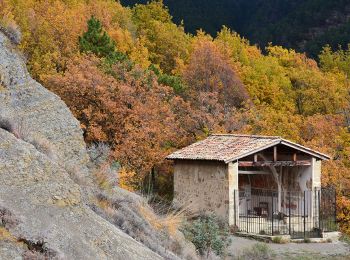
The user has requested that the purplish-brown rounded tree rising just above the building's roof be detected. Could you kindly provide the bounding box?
[183,40,248,132]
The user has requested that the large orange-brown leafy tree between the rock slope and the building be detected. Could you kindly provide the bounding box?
[49,56,183,189]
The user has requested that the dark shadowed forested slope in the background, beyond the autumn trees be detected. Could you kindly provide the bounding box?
[121,0,350,58]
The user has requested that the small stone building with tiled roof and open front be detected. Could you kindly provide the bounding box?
[167,134,330,238]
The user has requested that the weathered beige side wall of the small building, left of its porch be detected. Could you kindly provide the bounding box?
[174,160,232,221]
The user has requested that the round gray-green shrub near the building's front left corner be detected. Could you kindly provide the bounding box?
[182,215,230,257]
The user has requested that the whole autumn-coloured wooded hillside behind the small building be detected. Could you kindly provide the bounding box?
[0,0,350,235]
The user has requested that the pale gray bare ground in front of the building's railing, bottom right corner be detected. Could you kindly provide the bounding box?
[228,236,350,259]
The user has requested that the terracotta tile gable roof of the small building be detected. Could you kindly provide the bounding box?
[167,134,329,163]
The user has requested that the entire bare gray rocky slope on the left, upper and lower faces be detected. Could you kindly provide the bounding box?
[0,32,161,259]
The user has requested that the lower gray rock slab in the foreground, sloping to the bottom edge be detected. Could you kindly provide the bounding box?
[0,129,160,259]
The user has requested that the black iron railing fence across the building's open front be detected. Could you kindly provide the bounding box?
[234,189,337,238]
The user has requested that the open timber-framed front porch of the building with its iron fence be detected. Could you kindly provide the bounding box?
[233,144,337,238]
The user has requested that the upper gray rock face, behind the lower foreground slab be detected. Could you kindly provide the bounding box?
[0,31,88,169]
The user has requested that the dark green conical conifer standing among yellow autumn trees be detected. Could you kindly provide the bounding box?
[79,16,116,58]
